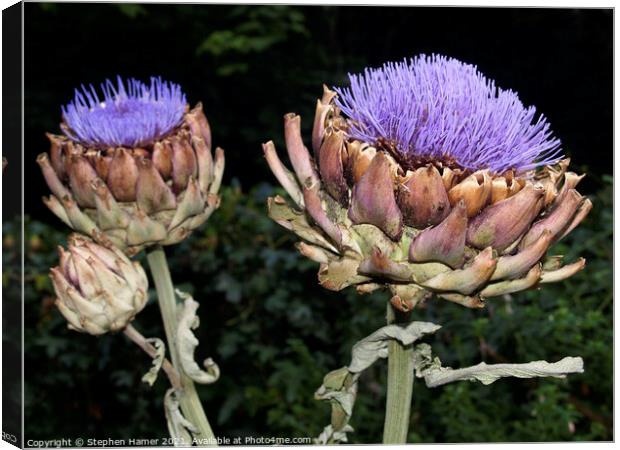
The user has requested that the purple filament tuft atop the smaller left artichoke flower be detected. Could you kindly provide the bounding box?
[62,77,187,148]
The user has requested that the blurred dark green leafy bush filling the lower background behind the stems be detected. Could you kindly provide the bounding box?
[13,178,613,443]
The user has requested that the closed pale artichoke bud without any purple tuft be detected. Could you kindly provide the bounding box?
[50,234,148,335]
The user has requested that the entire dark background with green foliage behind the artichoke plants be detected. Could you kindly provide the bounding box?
[12,4,613,443]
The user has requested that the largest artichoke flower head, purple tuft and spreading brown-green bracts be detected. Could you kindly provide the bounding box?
[263,55,592,311]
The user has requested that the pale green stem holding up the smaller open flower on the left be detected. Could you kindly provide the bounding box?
[147,246,215,445]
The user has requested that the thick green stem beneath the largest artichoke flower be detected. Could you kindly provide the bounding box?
[383,303,414,444]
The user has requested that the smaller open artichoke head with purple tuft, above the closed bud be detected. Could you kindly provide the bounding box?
[37,77,224,255]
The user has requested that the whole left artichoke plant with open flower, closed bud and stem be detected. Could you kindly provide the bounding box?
[37,77,224,445]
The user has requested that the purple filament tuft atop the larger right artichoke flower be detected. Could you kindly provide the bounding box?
[334,55,562,173]
